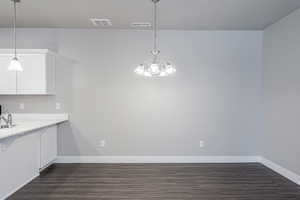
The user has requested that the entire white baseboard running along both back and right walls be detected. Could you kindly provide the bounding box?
[56,156,300,185]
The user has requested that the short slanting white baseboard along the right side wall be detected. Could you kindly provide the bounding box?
[260,157,300,185]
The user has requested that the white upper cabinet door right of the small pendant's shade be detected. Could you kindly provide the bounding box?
[17,54,46,94]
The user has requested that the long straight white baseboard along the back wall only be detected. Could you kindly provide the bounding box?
[56,156,259,163]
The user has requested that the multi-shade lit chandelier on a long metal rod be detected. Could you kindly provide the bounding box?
[134,0,176,77]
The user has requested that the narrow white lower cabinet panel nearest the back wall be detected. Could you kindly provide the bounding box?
[40,126,57,169]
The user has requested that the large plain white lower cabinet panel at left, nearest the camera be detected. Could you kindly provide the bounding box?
[0,133,40,199]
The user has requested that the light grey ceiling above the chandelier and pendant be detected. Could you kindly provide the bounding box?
[0,0,300,30]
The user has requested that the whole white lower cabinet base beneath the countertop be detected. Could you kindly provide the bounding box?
[0,125,57,200]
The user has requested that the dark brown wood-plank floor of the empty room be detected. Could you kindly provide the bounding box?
[9,163,300,200]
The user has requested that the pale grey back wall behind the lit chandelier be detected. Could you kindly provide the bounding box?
[0,29,262,156]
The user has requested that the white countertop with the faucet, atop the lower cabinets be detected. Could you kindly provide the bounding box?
[0,114,68,140]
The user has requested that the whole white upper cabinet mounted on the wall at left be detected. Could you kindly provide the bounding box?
[0,49,56,95]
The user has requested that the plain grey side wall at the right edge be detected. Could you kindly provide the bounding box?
[261,10,300,174]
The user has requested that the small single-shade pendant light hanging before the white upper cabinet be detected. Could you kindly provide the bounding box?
[8,0,23,72]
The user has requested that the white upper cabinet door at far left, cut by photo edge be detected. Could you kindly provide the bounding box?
[0,54,16,94]
